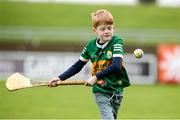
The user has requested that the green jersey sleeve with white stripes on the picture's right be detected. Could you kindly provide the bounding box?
[113,40,124,58]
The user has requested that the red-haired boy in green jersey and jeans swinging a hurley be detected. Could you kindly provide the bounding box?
[49,10,130,119]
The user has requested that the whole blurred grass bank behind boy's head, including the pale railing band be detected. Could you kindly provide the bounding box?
[0,1,180,46]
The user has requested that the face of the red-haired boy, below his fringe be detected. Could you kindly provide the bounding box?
[93,25,114,42]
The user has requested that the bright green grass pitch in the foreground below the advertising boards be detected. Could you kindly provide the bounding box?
[0,81,180,119]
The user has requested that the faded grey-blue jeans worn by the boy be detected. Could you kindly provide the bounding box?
[94,93,123,120]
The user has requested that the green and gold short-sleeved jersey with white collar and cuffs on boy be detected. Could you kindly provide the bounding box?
[80,35,130,94]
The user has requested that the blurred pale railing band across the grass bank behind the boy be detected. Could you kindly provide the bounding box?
[0,26,180,43]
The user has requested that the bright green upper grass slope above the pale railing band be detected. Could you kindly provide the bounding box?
[0,2,180,29]
